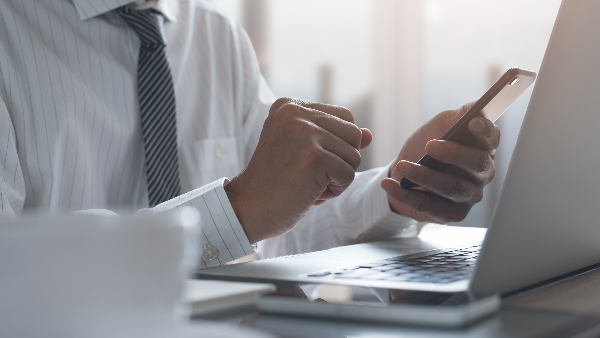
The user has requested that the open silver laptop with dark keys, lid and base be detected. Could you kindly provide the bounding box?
[197,0,600,296]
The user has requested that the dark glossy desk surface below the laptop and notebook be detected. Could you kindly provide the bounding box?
[196,229,600,338]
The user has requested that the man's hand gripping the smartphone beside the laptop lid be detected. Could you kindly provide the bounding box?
[381,103,500,224]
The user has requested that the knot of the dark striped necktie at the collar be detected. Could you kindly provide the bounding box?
[115,6,165,46]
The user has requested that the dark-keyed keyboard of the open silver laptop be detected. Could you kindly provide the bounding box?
[308,245,481,283]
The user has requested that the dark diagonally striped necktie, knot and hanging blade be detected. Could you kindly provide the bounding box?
[115,6,181,207]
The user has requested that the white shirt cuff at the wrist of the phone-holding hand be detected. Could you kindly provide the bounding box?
[363,163,427,237]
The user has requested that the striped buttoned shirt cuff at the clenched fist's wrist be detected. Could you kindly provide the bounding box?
[149,177,254,269]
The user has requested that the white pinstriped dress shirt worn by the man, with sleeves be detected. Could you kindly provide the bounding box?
[0,0,420,268]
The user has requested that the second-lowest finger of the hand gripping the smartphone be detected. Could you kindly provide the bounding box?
[396,161,483,203]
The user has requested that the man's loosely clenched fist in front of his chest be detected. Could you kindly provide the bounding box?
[225,98,372,243]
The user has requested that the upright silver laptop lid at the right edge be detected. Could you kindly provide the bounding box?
[471,0,600,295]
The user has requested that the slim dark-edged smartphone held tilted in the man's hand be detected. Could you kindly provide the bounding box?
[400,68,536,189]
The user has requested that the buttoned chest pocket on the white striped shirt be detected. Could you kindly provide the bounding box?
[181,137,242,191]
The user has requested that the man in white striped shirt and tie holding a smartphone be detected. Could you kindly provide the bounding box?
[0,0,500,268]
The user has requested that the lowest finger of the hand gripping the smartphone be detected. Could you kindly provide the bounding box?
[381,178,470,223]
